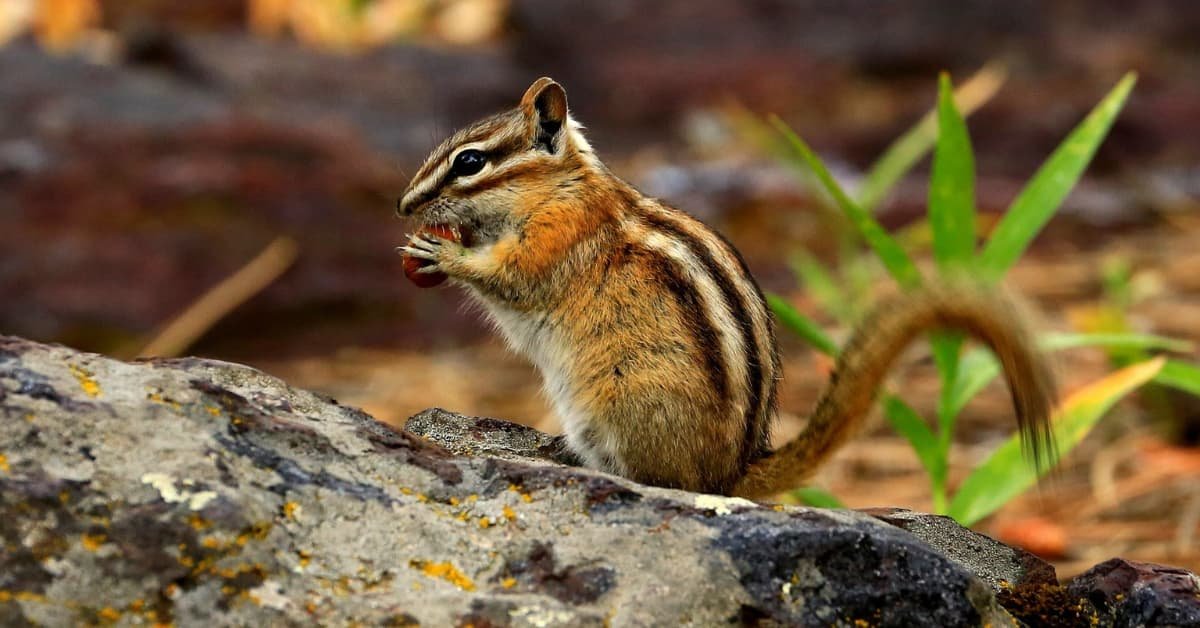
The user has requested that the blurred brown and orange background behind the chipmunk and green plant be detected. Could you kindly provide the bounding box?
[0,0,1200,576]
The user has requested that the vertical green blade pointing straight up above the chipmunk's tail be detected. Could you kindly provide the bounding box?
[929,72,976,271]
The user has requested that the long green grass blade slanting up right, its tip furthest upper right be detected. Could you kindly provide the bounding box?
[979,73,1136,280]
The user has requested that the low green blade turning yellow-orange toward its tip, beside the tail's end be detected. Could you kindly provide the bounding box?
[948,358,1166,526]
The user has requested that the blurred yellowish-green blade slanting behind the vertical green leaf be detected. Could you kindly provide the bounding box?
[857,64,1008,211]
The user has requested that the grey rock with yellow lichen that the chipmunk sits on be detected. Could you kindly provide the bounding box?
[0,336,1194,626]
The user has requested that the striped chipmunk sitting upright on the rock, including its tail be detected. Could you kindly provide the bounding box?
[397,78,1055,498]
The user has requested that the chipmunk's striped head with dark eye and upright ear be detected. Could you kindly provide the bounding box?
[396,77,596,245]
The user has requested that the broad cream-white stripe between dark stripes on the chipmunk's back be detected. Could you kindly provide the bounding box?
[643,231,756,415]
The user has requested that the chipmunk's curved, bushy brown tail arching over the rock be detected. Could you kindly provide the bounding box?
[731,285,1056,498]
